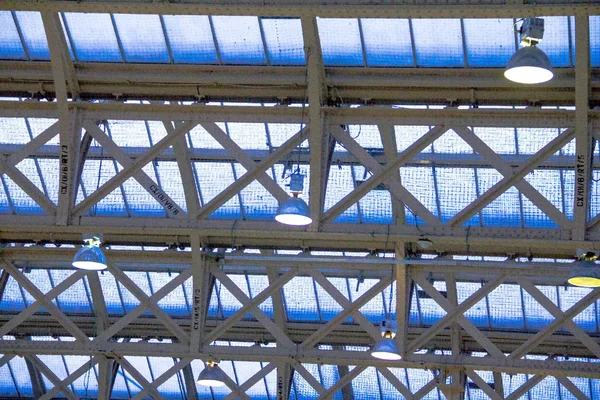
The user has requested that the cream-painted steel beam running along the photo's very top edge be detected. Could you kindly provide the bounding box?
[0,0,600,18]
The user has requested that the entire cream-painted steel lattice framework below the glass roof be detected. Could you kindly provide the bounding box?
[0,0,600,399]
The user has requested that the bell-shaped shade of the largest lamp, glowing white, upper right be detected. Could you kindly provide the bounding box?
[504,46,554,84]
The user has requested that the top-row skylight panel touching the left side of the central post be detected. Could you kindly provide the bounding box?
[260,18,306,65]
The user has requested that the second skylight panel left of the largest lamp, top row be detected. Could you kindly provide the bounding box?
[411,19,465,67]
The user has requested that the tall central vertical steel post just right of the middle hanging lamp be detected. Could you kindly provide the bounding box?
[302,17,329,231]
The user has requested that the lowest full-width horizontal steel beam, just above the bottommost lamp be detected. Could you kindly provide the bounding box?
[0,340,600,379]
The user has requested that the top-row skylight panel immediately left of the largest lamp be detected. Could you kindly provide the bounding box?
[463,18,516,67]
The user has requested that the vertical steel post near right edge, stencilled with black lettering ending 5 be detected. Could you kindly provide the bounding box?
[572,14,592,240]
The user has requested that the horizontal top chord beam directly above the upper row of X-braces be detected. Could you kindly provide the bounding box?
[0,101,580,129]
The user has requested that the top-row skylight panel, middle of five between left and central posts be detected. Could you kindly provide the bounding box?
[162,15,219,64]
